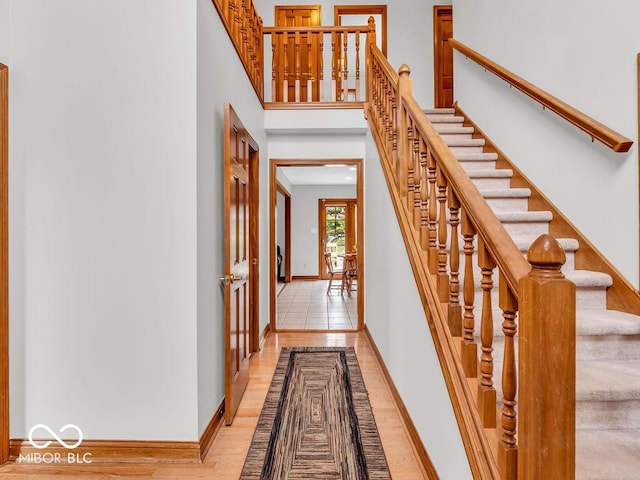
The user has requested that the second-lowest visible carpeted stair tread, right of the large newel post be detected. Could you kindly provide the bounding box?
[576,360,640,402]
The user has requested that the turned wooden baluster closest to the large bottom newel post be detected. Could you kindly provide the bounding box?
[498,272,516,480]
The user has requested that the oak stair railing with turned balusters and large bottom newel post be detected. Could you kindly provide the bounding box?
[365,38,575,480]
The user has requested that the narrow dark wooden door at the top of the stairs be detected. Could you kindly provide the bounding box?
[433,5,453,108]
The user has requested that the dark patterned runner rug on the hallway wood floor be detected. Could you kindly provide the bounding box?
[240,347,391,480]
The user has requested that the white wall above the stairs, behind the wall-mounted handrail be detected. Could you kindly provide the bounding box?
[453,0,640,287]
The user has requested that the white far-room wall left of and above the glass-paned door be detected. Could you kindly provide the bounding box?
[291,185,356,276]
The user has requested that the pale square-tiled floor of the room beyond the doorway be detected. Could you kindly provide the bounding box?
[276,280,358,330]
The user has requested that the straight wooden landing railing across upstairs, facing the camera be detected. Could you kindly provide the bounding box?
[263,18,375,108]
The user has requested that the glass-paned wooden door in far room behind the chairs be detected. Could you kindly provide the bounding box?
[318,199,358,279]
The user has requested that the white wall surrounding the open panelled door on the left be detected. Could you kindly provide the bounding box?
[197,0,269,434]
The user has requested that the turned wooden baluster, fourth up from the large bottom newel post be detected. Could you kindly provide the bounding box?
[447,188,462,337]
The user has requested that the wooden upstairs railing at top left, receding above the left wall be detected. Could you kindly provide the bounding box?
[212,0,264,102]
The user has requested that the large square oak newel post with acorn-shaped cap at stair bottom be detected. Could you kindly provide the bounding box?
[518,235,576,480]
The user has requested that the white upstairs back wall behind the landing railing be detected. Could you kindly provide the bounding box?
[254,0,451,108]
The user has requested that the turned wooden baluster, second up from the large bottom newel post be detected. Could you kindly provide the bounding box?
[478,240,496,428]
